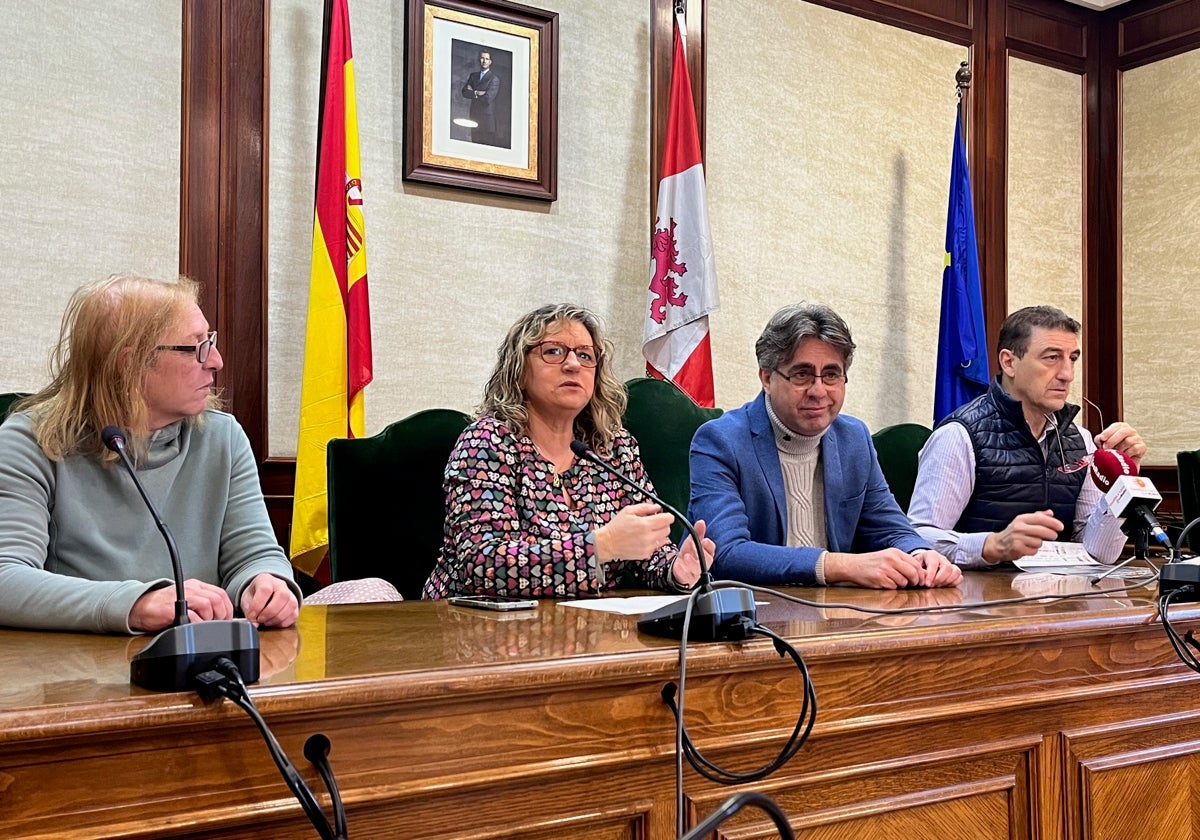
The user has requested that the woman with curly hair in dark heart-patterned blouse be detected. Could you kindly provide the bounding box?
[424,305,714,598]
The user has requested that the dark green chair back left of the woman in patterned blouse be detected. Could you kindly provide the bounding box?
[326,408,472,599]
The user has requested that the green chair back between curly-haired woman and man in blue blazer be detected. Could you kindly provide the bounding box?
[623,377,722,541]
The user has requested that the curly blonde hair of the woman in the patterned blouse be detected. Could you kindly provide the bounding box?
[478,304,626,455]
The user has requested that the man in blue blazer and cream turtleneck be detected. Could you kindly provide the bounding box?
[689,304,962,589]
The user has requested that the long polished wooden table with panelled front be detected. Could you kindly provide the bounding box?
[0,572,1200,840]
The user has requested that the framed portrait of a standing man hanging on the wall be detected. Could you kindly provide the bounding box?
[404,0,558,202]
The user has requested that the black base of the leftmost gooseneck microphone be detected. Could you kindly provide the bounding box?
[130,619,258,691]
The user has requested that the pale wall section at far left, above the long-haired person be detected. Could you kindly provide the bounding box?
[0,0,182,391]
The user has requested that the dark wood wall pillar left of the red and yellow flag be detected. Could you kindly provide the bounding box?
[179,0,268,461]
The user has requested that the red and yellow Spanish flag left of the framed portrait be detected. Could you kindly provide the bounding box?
[290,0,372,575]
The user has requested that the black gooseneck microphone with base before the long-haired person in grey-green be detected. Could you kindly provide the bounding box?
[100,426,259,691]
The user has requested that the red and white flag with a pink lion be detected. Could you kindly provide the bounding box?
[642,16,719,408]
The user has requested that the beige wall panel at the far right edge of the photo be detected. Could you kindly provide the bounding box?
[1121,50,1200,463]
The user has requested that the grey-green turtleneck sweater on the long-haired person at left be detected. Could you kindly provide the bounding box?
[0,410,300,632]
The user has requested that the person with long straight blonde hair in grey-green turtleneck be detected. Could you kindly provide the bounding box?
[0,275,300,632]
